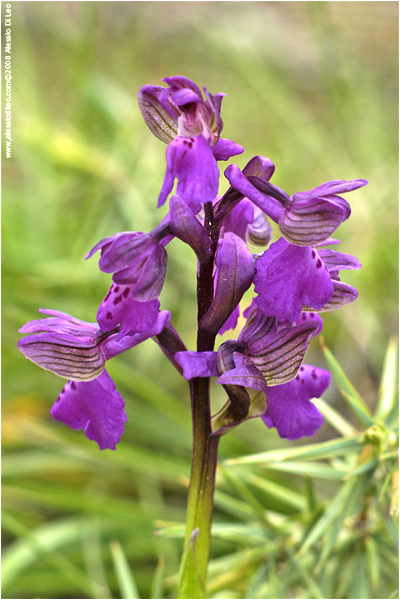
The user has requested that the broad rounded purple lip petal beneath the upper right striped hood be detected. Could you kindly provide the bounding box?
[254,238,333,321]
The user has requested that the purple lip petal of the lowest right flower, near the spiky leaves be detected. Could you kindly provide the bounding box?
[263,365,330,440]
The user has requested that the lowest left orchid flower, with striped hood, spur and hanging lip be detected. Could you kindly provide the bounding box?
[18,310,171,450]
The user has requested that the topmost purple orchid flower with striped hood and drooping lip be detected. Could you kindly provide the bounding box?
[138,76,243,212]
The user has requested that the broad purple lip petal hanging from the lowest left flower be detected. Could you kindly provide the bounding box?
[51,371,127,450]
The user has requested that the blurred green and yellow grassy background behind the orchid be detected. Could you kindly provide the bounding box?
[2,2,398,598]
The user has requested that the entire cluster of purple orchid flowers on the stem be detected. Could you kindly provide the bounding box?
[19,76,367,460]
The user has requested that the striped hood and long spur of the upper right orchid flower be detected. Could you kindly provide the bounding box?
[225,165,368,246]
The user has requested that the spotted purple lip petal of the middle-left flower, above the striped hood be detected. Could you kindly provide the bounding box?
[97,283,160,340]
